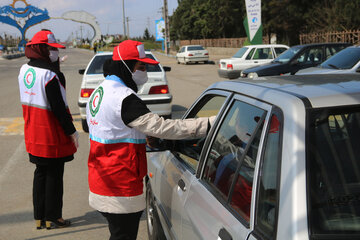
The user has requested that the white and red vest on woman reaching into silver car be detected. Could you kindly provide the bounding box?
[86,79,147,197]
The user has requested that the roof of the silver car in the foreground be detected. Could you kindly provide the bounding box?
[211,74,360,107]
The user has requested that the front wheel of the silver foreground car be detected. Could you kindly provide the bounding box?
[146,181,166,240]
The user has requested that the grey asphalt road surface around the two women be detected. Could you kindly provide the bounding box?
[0,49,223,240]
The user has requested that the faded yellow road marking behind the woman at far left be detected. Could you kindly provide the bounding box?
[0,115,83,136]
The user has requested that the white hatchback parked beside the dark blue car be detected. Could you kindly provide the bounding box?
[218,44,289,79]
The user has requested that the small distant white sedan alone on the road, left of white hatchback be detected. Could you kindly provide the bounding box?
[176,45,209,64]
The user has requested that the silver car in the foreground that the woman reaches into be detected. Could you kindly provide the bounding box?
[146,74,360,240]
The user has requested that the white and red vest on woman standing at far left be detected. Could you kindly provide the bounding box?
[18,64,76,158]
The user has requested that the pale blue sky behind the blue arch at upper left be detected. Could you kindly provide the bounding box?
[0,0,178,41]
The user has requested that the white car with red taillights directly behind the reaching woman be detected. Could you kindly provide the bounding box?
[78,51,172,132]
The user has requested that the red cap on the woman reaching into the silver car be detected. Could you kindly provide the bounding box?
[113,40,159,65]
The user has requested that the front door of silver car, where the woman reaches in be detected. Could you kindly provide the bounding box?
[147,90,230,239]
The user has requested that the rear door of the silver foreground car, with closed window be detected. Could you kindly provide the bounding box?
[182,95,271,240]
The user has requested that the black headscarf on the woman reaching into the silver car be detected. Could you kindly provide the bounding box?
[103,59,138,92]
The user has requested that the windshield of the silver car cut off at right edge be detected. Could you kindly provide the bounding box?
[321,47,360,69]
